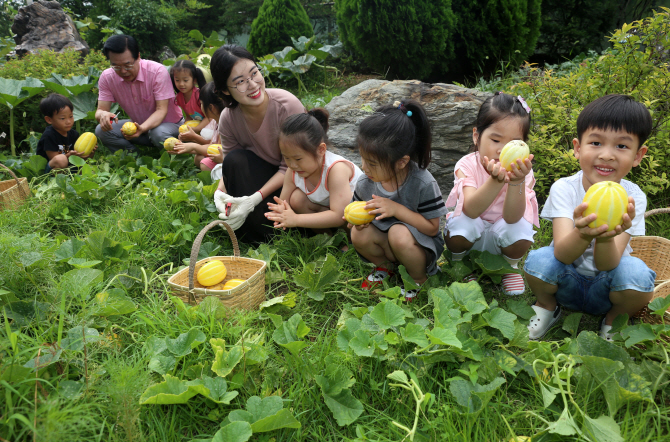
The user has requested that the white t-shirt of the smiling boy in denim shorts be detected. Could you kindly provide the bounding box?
[540,170,647,276]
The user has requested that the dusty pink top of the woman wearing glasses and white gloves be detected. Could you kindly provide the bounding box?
[219,89,306,173]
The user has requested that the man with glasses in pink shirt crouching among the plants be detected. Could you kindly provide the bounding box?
[95,35,184,153]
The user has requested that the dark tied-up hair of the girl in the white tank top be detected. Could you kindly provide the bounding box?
[279,107,330,157]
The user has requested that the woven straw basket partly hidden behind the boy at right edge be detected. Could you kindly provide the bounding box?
[630,207,670,323]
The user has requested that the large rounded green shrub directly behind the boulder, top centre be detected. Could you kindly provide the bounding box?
[335,0,456,79]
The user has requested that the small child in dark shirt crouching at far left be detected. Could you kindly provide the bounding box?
[37,94,98,173]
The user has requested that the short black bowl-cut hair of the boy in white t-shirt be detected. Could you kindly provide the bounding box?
[577,94,653,149]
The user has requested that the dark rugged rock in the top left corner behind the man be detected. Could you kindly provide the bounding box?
[12,0,90,57]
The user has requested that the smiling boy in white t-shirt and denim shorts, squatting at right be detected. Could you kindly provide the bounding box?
[524,95,656,340]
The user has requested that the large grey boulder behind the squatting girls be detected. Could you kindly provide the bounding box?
[326,80,491,198]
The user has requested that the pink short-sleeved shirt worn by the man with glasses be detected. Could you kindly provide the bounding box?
[98,59,182,124]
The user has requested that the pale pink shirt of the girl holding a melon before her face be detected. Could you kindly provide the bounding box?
[446,152,540,227]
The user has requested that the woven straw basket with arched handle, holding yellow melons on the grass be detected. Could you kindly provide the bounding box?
[168,220,266,310]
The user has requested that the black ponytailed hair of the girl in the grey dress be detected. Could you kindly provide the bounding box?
[356,100,432,183]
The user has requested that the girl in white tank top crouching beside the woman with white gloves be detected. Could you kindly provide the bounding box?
[265,108,363,230]
